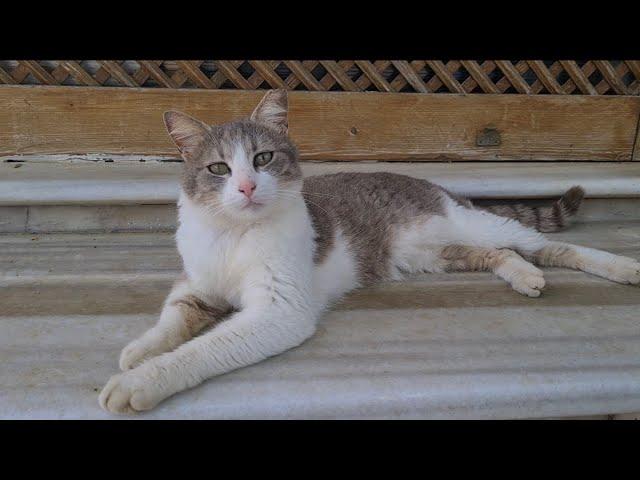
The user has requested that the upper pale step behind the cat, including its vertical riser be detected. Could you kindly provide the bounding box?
[0,155,640,233]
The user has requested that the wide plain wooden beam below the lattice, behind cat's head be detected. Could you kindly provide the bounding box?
[0,86,640,161]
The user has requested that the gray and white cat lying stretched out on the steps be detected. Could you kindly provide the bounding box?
[99,90,640,413]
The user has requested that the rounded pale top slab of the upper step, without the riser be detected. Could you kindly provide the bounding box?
[5,155,640,205]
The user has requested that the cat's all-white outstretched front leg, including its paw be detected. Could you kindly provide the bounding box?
[99,302,315,413]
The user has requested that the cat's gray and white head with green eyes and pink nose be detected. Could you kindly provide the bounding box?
[164,90,302,221]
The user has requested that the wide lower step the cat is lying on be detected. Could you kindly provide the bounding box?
[0,222,640,418]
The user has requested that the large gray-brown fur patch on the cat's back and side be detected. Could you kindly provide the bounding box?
[302,172,447,285]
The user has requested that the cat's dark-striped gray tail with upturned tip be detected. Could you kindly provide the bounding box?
[478,187,584,232]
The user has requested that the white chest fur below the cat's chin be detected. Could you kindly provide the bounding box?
[176,192,313,307]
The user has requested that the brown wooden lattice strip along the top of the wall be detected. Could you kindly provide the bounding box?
[0,60,640,95]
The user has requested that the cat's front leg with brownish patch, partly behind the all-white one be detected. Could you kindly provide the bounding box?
[119,278,231,371]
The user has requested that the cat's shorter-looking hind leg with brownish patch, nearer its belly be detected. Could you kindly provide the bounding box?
[440,245,545,297]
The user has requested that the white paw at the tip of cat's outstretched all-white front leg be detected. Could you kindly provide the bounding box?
[98,369,169,414]
